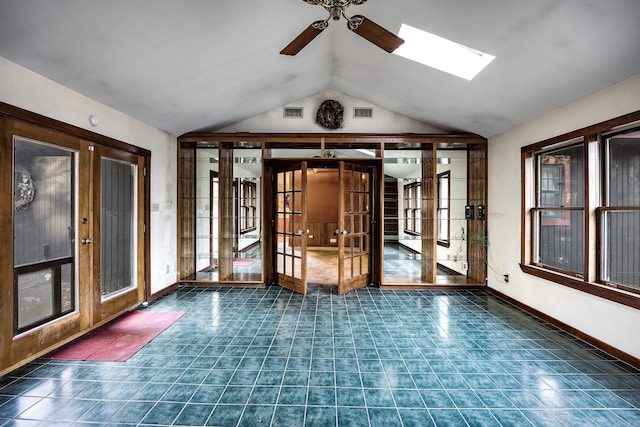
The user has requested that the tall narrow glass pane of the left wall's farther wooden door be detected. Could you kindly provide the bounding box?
[100,158,137,298]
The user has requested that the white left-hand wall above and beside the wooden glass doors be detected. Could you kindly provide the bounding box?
[0,57,177,293]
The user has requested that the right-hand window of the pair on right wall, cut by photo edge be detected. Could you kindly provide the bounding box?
[598,129,640,292]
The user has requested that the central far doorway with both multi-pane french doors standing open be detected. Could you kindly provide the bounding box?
[265,159,380,294]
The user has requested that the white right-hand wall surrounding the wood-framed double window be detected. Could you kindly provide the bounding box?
[488,75,640,358]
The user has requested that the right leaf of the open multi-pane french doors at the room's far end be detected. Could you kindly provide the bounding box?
[336,162,373,295]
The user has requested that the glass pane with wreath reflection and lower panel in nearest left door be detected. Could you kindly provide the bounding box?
[13,138,76,333]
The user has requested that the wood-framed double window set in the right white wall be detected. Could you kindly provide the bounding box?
[520,112,640,308]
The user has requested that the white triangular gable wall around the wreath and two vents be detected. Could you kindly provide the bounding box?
[216,90,443,133]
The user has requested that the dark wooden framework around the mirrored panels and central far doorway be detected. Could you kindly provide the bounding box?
[177,132,488,289]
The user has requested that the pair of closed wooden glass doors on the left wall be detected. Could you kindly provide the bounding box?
[0,117,146,375]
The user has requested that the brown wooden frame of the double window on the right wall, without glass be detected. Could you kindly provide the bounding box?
[520,111,640,309]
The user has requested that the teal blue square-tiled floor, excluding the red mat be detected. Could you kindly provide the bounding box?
[0,286,640,427]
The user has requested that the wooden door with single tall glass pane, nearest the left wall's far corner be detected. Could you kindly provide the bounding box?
[89,146,145,324]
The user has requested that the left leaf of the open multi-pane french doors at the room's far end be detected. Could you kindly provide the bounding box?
[274,161,307,294]
